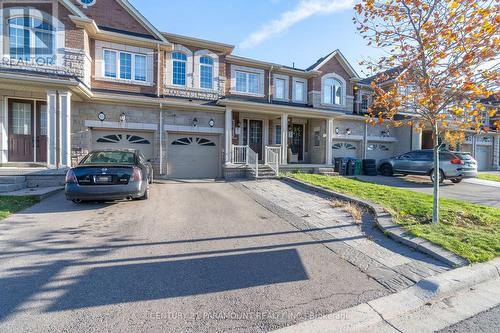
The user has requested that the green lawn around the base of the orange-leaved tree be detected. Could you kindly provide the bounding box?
[288,173,500,262]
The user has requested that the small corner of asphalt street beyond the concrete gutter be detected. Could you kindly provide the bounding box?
[439,306,500,333]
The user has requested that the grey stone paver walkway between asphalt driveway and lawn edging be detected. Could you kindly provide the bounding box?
[241,180,449,291]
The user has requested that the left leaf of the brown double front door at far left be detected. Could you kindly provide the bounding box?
[8,99,35,162]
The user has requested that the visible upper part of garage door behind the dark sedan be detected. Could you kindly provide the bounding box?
[92,129,153,159]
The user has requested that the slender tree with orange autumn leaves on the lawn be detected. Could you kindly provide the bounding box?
[354,0,500,223]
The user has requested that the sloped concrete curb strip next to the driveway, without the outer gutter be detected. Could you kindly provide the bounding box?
[274,258,500,333]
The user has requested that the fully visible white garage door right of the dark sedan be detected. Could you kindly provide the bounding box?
[167,134,221,178]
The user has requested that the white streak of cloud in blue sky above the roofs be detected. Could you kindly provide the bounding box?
[240,0,354,49]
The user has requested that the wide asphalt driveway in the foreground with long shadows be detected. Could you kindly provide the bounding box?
[0,182,388,332]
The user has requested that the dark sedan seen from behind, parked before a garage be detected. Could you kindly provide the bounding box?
[65,149,153,203]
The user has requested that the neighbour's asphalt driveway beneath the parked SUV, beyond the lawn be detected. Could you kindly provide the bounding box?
[356,176,500,207]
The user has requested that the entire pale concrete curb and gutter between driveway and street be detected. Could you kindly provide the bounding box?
[275,259,500,333]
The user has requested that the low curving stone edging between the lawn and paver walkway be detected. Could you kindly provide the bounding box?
[282,177,470,267]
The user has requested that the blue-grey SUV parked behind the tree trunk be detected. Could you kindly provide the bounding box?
[379,149,470,184]
